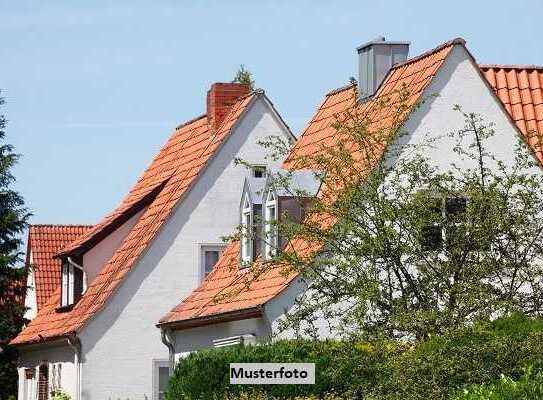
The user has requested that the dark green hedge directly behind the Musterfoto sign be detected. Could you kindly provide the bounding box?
[166,340,398,400]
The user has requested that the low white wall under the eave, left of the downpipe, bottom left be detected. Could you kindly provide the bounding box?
[17,343,77,400]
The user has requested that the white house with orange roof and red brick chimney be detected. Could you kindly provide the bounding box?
[11,83,293,400]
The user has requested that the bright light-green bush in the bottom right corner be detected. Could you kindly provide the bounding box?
[455,370,543,400]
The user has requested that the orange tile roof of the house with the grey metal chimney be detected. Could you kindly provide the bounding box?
[159,39,465,327]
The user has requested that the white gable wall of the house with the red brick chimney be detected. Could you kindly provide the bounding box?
[76,98,294,400]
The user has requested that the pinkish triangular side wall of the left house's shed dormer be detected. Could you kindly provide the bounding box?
[83,209,145,286]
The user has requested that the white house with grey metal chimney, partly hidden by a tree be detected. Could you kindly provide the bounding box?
[158,38,543,360]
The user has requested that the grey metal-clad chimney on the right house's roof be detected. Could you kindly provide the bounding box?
[356,36,409,100]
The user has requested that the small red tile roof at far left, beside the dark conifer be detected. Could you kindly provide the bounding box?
[27,225,91,311]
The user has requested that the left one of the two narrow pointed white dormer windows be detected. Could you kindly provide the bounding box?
[240,176,266,265]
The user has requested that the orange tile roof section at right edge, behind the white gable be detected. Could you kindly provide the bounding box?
[480,65,543,162]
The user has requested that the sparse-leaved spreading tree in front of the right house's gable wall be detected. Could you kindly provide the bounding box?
[244,89,543,339]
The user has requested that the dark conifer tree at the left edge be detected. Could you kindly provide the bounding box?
[0,91,29,399]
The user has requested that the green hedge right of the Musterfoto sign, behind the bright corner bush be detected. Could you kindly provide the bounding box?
[373,315,543,400]
